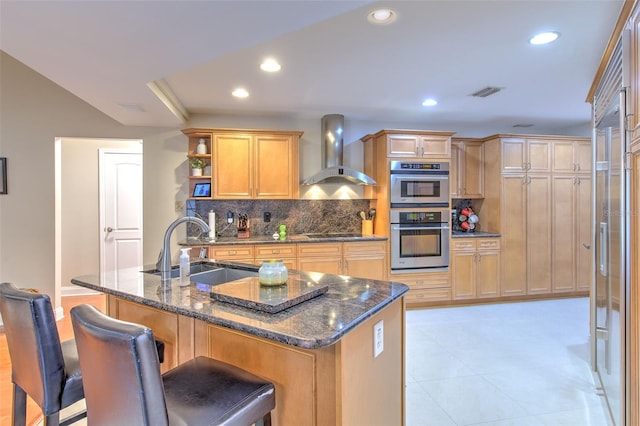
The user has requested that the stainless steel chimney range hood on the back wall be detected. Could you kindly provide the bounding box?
[302,114,376,185]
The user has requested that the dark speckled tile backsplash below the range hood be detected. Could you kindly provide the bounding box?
[187,199,369,237]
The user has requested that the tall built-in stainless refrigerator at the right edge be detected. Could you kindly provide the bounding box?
[591,37,630,426]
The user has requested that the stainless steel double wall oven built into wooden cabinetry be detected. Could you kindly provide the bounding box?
[390,161,450,273]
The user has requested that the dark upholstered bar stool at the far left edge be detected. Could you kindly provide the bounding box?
[0,283,86,426]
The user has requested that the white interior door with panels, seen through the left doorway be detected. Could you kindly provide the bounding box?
[100,150,143,278]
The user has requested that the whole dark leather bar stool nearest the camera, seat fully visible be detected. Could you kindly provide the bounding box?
[71,305,275,426]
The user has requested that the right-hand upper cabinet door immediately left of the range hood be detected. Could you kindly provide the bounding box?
[252,135,299,199]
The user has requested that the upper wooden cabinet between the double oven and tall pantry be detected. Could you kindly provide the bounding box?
[449,139,484,199]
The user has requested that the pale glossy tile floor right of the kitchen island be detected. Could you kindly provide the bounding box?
[406,298,611,426]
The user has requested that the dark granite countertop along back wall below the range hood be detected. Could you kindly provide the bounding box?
[178,233,388,246]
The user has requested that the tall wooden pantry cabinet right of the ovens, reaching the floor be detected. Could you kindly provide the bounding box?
[482,135,591,296]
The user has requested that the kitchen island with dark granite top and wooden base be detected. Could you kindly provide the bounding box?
[72,261,408,425]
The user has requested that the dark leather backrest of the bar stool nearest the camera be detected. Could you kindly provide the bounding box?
[71,305,168,426]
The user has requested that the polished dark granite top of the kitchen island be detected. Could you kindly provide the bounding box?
[71,261,409,349]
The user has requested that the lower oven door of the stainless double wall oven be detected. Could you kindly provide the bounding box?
[390,223,449,272]
